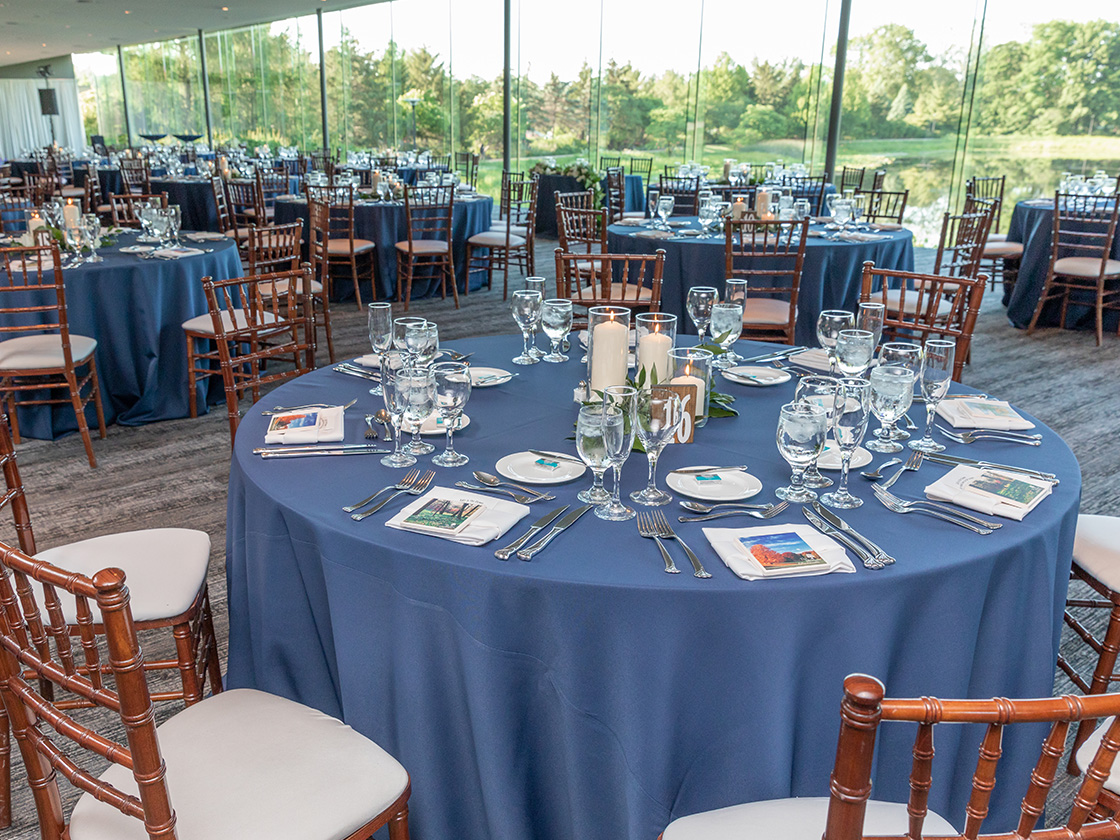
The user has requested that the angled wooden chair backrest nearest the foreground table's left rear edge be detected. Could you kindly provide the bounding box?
[202,263,315,447]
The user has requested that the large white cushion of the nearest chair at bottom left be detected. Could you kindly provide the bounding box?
[69,689,409,840]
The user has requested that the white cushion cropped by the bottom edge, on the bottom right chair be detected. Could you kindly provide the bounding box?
[662,796,956,840]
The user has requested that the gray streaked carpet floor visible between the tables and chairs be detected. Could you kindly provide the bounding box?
[0,240,1120,840]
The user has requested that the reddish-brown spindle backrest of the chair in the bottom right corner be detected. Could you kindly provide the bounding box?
[823,674,1120,840]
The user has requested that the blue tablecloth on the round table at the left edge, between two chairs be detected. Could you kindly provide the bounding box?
[0,234,242,440]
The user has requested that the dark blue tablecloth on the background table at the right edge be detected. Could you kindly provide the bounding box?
[1004,198,1120,333]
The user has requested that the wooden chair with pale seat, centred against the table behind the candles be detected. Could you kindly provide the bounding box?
[724,218,809,344]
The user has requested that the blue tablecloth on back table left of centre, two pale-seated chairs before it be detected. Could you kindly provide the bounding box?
[276,196,494,300]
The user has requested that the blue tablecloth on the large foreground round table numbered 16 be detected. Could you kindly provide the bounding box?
[226,336,1080,840]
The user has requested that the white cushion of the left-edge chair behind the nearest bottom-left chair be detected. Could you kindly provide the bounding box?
[36,528,211,624]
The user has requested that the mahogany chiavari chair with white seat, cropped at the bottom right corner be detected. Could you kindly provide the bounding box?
[662,674,1120,840]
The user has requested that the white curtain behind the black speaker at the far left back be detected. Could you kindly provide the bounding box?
[0,78,85,160]
